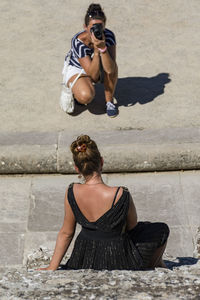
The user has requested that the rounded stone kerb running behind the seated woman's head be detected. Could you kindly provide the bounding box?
[0,128,200,174]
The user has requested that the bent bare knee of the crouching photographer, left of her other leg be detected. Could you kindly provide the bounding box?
[67,74,95,105]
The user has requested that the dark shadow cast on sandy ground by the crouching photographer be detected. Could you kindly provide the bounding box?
[71,73,171,116]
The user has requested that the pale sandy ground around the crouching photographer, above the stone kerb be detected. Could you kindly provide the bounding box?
[0,0,200,132]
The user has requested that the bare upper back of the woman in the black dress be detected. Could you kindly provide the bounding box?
[73,184,123,222]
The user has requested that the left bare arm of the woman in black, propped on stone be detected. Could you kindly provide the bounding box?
[38,191,76,271]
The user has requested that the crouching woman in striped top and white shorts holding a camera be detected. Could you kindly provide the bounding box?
[63,4,118,117]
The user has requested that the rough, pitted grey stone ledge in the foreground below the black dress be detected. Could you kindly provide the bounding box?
[0,260,200,300]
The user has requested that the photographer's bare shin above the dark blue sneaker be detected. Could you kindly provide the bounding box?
[104,67,118,102]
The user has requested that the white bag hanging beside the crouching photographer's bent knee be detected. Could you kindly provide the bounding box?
[60,85,74,113]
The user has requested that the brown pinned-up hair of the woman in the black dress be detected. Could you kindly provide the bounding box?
[70,135,101,176]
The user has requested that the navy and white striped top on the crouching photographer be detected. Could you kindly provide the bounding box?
[65,28,116,69]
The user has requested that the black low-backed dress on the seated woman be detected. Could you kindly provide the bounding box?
[65,184,170,270]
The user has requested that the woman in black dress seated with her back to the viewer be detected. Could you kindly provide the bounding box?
[40,135,169,270]
